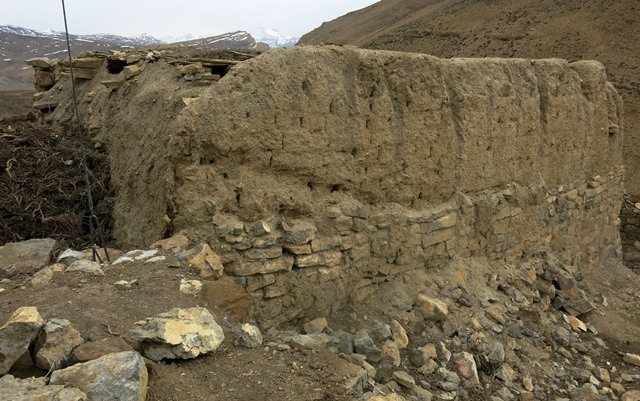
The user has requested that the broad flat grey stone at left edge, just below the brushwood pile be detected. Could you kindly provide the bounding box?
[0,238,56,278]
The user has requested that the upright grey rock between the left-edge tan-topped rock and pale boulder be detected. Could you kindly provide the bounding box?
[35,319,84,370]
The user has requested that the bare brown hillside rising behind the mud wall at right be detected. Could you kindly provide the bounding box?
[300,0,640,195]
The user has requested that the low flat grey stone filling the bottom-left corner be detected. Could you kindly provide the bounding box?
[0,375,87,401]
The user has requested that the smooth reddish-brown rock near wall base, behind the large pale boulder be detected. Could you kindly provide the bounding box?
[204,280,251,322]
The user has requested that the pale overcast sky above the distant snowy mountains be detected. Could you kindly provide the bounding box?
[0,0,376,38]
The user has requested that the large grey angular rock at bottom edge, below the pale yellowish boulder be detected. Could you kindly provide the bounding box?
[50,352,148,401]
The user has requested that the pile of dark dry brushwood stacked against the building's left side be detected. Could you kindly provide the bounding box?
[0,123,110,245]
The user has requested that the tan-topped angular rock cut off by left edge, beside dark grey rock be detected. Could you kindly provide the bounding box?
[0,307,44,375]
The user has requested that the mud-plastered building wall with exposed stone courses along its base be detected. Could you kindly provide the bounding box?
[30,46,623,325]
